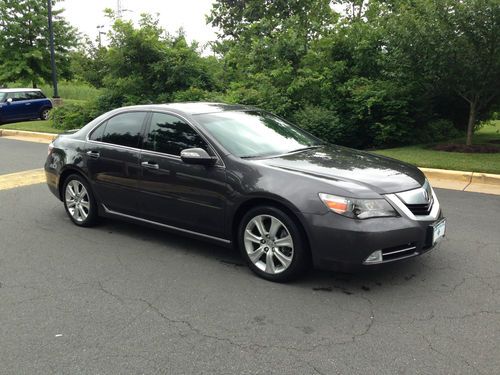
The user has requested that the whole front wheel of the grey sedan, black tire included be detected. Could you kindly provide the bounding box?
[237,206,310,282]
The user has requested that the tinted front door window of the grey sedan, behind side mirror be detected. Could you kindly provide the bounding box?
[144,113,209,155]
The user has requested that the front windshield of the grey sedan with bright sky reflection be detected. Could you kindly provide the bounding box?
[194,111,323,158]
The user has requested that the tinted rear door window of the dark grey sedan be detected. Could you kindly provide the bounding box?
[97,112,146,147]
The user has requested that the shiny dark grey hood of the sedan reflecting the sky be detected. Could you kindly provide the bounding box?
[252,146,425,194]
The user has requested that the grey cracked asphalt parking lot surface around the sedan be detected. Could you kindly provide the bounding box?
[0,138,500,374]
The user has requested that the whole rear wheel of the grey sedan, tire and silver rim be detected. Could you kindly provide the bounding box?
[62,174,98,227]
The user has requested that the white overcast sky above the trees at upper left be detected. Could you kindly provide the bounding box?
[57,0,215,46]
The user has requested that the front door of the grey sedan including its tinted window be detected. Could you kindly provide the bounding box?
[139,113,226,237]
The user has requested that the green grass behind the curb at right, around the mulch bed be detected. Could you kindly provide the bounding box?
[374,121,500,174]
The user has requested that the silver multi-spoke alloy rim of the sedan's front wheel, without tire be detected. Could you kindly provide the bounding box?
[244,215,294,275]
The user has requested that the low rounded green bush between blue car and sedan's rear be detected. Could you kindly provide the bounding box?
[51,102,99,130]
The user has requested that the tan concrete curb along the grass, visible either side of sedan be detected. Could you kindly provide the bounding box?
[0,129,500,195]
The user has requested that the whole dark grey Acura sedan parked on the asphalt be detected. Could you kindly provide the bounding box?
[45,103,446,281]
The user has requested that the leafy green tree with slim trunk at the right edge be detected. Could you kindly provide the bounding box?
[387,0,500,145]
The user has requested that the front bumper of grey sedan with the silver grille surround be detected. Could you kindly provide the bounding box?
[304,189,443,269]
